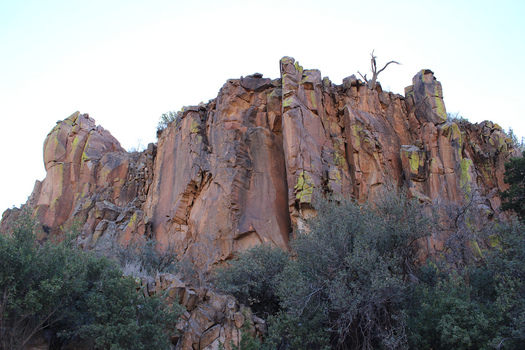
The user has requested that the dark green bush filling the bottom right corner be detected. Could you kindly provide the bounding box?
[406,222,525,349]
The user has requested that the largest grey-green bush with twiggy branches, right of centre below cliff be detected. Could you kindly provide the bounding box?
[272,190,431,349]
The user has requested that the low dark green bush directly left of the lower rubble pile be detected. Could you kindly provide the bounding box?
[79,262,182,350]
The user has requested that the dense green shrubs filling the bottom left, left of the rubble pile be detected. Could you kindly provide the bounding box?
[0,215,180,350]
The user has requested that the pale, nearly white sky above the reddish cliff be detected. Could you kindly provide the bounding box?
[0,0,525,212]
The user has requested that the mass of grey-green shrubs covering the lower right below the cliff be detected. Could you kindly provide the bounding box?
[216,191,525,349]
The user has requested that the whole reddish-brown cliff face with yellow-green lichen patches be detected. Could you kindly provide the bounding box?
[4,57,516,263]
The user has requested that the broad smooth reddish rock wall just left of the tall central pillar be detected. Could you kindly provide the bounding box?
[145,74,291,263]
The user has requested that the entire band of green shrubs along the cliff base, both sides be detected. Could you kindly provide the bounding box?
[4,154,525,350]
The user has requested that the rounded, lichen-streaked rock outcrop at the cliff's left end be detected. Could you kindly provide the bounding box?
[4,112,156,249]
